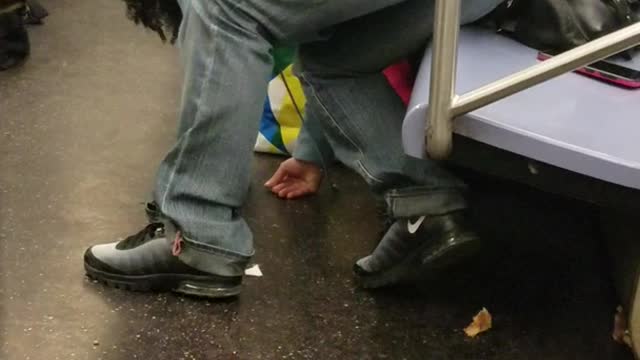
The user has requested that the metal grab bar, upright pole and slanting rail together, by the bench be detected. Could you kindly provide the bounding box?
[425,0,640,159]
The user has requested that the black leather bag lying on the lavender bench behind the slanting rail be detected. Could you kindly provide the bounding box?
[493,0,640,51]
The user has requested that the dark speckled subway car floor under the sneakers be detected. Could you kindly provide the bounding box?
[0,0,632,360]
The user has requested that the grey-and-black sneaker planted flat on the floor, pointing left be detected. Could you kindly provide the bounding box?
[84,222,242,298]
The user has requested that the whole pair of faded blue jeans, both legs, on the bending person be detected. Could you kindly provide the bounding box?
[154,0,500,276]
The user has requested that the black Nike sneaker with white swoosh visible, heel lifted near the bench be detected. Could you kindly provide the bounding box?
[354,211,480,288]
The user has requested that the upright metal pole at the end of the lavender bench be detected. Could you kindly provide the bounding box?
[426,0,461,159]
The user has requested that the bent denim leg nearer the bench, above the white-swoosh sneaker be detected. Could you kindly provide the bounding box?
[298,0,500,217]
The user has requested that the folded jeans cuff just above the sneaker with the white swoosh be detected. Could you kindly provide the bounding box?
[384,187,467,218]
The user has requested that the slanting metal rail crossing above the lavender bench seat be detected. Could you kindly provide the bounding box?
[450,21,640,116]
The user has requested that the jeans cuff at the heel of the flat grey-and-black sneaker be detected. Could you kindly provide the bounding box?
[163,220,253,276]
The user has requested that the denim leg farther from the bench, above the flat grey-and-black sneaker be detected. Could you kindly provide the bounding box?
[154,0,412,275]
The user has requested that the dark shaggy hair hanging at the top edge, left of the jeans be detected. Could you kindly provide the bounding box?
[123,0,182,43]
